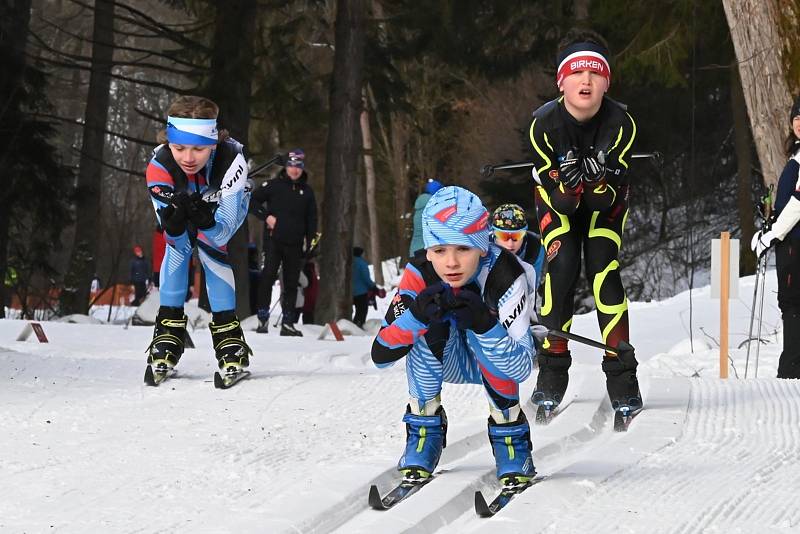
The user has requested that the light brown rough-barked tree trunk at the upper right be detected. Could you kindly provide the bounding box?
[722,0,792,185]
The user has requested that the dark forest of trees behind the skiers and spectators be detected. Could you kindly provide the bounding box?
[0,0,800,322]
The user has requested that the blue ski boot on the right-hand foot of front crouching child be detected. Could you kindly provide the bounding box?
[489,408,536,488]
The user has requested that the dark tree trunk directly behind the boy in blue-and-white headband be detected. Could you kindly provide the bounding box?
[208,0,257,319]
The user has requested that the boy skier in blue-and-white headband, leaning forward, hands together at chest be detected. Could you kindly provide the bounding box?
[147,96,251,382]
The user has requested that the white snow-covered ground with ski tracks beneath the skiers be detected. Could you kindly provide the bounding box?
[0,272,800,534]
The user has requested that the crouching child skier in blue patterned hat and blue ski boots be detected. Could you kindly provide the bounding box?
[372,187,536,485]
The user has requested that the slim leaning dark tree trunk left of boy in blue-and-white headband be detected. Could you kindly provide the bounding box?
[61,0,116,313]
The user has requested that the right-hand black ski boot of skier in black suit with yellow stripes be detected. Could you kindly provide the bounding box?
[603,341,643,431]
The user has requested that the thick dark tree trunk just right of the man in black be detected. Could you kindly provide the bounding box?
[317,0,366,323]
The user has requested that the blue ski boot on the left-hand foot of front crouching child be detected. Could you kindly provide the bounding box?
[397,405,447,481]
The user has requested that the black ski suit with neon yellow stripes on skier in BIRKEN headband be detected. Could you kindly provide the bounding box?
[530,97,638,410]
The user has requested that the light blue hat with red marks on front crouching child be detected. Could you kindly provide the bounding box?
[422,186,490,252]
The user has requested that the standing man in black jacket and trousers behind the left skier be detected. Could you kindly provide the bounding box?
[250,148,317,336]
